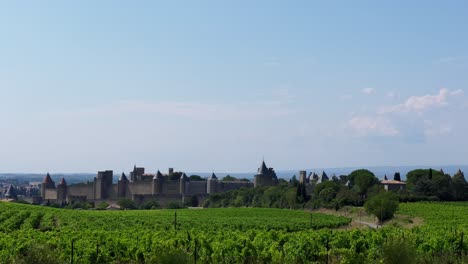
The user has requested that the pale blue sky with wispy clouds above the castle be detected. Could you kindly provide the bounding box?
[0,0,468,173]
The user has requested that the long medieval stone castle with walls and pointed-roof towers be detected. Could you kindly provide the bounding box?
[41,161,278,204]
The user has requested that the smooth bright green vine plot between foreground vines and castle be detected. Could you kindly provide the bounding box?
[0,203,350,231]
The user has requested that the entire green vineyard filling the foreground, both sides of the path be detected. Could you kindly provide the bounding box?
[0,203,468,263]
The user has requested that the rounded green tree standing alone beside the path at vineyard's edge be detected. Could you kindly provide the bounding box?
[364,191,399,223]
